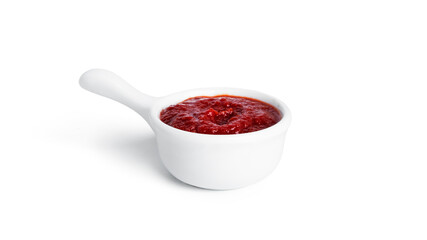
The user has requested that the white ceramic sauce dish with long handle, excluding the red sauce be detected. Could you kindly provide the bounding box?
[80,69,291,190]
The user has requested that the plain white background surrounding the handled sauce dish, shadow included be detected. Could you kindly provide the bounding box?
[0,0,427,240]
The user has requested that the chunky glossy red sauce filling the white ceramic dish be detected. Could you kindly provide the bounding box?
[160,95,282,134]
